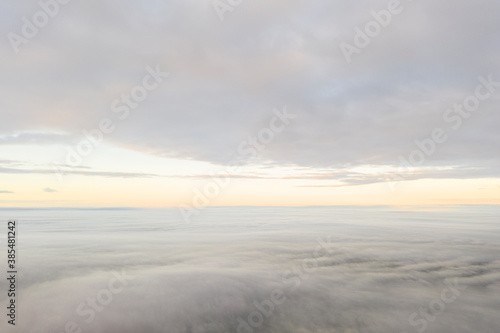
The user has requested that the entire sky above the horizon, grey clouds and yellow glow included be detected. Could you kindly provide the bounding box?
[0,0,500,208]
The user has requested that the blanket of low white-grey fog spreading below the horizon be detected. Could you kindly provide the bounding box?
[0,207,500,333]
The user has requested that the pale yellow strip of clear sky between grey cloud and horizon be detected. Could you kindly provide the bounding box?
[0,145,500,207]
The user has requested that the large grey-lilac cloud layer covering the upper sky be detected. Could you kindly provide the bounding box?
[0,0,500,177]
